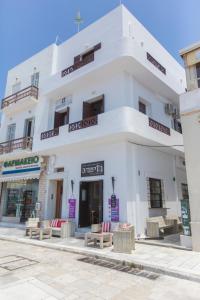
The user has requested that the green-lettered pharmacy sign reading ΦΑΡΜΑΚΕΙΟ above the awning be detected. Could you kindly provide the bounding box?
[1,156,41,175]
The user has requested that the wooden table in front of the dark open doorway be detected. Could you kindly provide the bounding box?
[85,232,112,249]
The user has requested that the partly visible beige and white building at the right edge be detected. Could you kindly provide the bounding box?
[180,42,200,251]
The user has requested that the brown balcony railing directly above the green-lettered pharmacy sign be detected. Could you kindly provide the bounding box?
[0,137,33,155]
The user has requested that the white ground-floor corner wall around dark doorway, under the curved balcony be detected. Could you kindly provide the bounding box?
[44,142,185,235]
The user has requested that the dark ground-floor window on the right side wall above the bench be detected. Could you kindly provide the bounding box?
[149,178,163,208]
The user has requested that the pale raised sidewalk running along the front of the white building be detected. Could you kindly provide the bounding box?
[0,227,200,282]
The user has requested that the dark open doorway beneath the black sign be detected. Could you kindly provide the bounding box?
[79,180,103,227]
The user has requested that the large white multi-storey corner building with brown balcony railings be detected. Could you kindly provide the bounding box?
[0,5,187,235]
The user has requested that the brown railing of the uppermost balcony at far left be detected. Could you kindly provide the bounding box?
[1,86,38,109]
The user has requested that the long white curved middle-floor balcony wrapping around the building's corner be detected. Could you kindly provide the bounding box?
[33,107,183,154]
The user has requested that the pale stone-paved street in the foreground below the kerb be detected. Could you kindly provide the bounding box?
[0,241,200,300]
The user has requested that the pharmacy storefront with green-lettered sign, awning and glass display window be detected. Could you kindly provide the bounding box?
[0,156,41,223]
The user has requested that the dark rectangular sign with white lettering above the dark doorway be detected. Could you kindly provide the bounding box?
[81,161,104,177]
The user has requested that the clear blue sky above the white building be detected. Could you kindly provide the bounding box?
[0,0,200,98]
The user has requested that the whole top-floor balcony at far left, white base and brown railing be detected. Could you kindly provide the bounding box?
[1,86,38,114]
